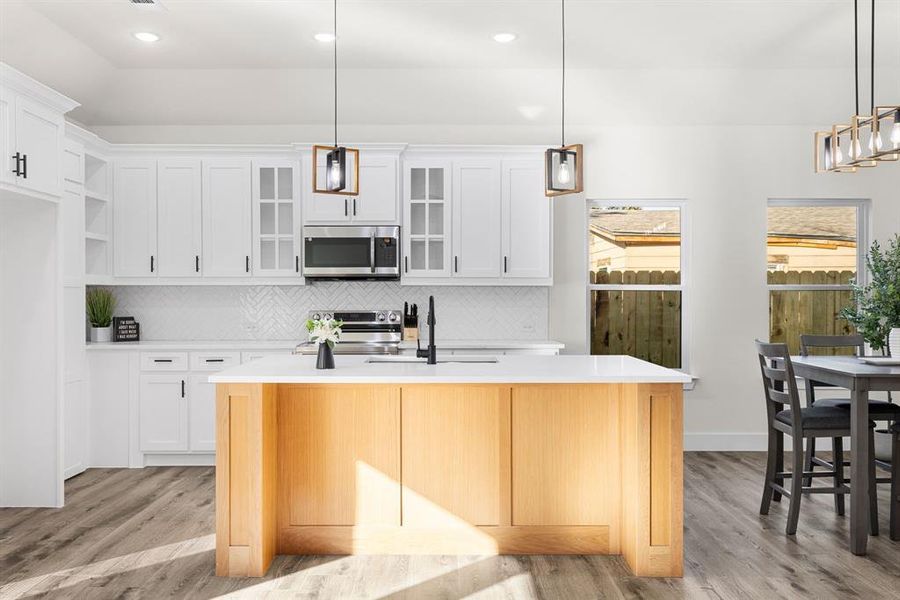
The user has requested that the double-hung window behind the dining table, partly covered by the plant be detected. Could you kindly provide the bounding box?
[766,199,869,354]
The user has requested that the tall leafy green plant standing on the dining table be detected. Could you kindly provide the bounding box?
[841,234,900,353]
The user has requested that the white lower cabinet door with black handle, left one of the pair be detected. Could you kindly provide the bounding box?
[138,373,188,452]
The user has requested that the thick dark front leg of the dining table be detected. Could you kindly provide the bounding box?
[850,380,870,556]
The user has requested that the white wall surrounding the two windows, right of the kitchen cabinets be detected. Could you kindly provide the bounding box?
[550,127,900,449]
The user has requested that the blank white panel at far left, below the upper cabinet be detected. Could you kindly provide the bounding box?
[0,192,63,506]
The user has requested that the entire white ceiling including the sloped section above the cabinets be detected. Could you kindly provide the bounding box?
[0,0,900,134]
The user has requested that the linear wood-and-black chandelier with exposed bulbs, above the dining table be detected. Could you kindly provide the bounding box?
[815,0,900,173]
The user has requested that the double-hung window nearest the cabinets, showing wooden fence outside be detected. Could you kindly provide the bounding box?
[587,199,690,370]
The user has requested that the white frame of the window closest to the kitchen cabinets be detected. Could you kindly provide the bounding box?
[581,198,691,375]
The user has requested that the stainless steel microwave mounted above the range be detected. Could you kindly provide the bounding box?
[303,225,400,279]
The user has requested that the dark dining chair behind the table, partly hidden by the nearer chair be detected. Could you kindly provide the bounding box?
[800,334,900,485]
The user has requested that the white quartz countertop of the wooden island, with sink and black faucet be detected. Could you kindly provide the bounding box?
[209,351,691,384]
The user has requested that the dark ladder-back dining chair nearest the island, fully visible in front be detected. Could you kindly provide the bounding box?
[756,340,878,535]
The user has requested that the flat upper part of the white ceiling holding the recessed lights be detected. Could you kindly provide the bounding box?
[5,0,900,69]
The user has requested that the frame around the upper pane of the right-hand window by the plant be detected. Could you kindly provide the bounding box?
[764,198,872,296]
